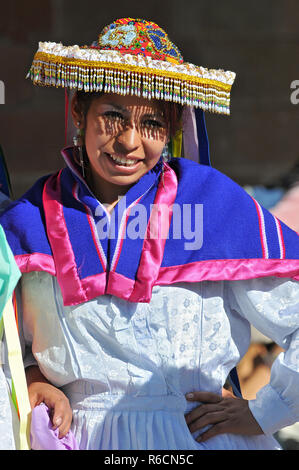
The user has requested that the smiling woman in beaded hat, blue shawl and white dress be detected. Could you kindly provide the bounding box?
[1,18,299,450]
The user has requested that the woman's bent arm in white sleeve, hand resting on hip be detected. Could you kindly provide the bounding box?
[186,278,299,442]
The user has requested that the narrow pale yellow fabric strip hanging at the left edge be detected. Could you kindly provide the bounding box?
[3,297,31,450]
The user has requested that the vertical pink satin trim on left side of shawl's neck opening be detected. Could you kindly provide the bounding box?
[43,170,87,305]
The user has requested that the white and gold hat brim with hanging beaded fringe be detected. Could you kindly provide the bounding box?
[27,20,235,114]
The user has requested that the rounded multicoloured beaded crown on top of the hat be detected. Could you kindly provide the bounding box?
[93,18,184,64]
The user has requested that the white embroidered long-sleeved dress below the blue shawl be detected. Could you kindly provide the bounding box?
[20,272,299,450]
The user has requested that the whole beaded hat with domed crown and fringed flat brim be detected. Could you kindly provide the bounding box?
[28,18,235,114]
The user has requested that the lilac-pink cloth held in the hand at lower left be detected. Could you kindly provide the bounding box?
[30,403,79,450]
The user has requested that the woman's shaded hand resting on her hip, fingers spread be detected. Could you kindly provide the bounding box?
[185,392,263,442]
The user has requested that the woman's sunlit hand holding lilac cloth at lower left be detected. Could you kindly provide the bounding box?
[26,366,72,438]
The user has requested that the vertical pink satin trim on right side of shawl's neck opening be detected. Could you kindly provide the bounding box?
[128,164,178,302]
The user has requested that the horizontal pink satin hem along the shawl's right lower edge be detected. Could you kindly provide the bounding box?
[155,259,299,285]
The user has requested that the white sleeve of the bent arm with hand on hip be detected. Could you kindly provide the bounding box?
[229,277,299,434]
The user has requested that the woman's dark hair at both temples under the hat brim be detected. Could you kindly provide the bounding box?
[76,91,183,137]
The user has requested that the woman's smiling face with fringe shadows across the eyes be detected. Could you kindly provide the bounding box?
[73,94,168,202]
